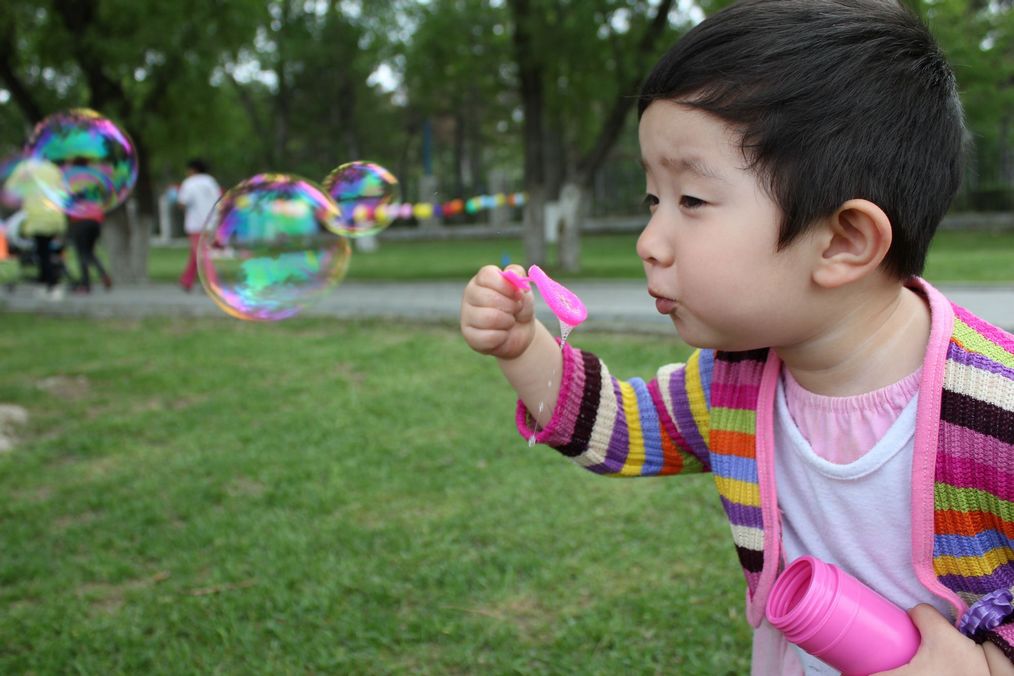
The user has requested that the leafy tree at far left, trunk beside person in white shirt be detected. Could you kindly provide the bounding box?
[0,0,259,282]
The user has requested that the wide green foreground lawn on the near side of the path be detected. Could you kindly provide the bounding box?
[0,314,749,675]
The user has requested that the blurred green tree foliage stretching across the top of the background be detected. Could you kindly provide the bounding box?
[0,0,1014,211]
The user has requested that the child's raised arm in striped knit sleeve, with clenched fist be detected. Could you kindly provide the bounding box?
[461,266,713,476]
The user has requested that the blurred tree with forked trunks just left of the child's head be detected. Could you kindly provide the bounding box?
[509,0,673,271]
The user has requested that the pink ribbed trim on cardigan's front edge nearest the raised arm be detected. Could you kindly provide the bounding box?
[746,350,782,628]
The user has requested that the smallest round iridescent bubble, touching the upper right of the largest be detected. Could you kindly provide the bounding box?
[323,162,399,237]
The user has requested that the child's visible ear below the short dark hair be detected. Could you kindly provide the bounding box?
[813,200,892,289]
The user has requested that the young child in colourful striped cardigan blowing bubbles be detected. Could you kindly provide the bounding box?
[461,0,1014,675]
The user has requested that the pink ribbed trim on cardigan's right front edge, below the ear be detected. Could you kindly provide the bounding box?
[911,278,968,619]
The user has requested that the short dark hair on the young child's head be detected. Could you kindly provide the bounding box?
[638,0,964,279]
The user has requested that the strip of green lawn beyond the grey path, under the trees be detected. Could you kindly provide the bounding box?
[140,230,1014,284]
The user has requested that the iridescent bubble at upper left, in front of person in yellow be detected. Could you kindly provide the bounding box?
[24,108,137,218]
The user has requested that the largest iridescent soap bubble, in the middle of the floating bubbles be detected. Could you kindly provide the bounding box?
[197,173,352,321]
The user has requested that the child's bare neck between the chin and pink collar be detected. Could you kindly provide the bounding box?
[776,284,930,396]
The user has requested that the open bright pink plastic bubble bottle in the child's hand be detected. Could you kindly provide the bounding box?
[765,556,920,676]
